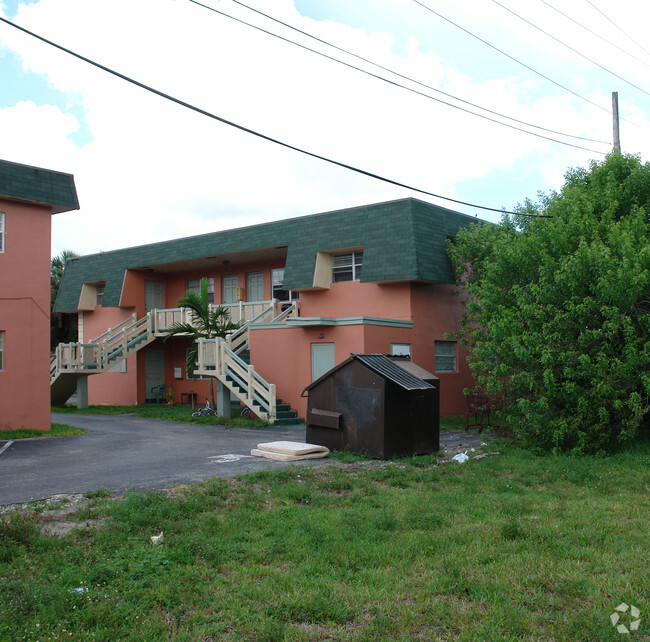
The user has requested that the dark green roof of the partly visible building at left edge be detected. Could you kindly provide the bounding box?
[0,160,79,214]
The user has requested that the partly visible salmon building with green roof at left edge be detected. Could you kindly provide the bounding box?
[0,161,79,431]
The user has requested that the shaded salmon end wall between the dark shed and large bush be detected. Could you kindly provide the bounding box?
[411,283,474,415]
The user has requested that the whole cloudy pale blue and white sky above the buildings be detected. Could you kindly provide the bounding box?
[0,0,650,255]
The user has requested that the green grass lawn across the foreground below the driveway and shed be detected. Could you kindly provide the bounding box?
[0,432,650,641]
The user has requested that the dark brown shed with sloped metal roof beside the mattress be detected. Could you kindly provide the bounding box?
[303,354,440,459]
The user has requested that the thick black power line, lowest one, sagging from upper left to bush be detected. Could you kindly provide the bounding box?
[0,16,551,218]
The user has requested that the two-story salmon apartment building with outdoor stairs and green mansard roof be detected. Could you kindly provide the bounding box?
[52,198,476,421]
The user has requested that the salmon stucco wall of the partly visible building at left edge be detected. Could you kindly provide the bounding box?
[0,201,52,430]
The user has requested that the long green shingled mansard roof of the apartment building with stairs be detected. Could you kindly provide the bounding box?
[54,198,476,312]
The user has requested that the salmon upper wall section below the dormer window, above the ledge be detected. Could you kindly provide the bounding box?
[300,281,411,320]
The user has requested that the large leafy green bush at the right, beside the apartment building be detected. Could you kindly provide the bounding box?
[450,154,650,453]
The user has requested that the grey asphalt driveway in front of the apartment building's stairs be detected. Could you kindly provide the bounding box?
[0,414,327,506]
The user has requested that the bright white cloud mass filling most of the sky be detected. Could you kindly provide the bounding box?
[0,0,648,253]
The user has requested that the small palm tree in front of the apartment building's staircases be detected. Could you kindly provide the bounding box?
[164,278,240,408]
